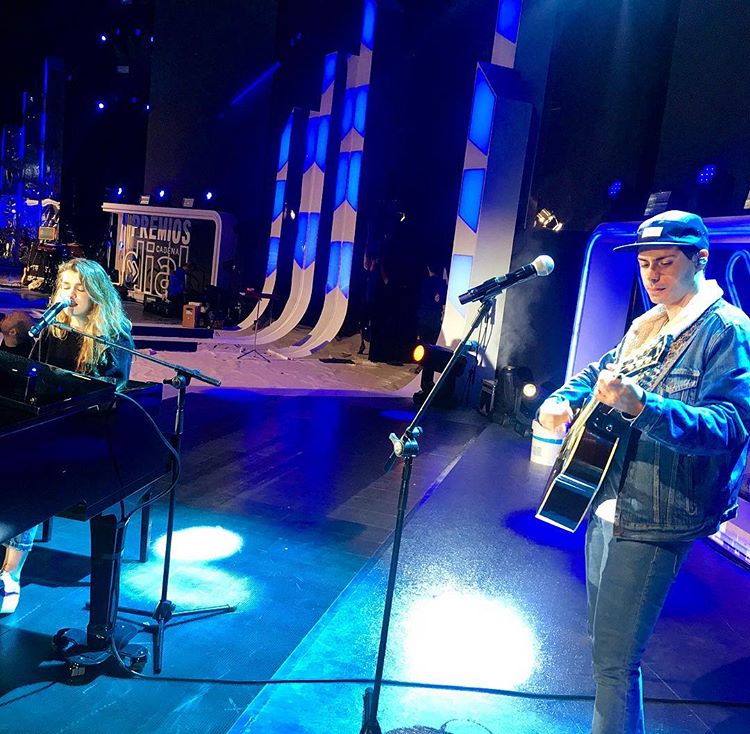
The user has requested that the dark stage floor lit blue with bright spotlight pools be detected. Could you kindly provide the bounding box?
[0,388,750,734]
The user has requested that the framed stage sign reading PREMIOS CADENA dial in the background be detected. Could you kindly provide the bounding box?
[102,203,234,301]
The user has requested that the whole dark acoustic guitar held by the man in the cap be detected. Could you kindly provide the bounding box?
[536,336,672,533]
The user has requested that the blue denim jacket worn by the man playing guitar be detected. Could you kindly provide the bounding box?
[553,299,750,541]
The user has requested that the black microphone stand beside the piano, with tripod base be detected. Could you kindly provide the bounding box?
[53,321,237,673]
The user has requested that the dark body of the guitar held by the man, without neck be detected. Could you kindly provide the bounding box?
[536,405,628,533]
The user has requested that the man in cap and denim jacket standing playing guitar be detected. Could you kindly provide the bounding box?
[539,211,750,734]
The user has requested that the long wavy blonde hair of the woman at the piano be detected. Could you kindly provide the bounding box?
[50,257,132,374]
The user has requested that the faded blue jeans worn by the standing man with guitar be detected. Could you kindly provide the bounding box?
[586,515,693,734]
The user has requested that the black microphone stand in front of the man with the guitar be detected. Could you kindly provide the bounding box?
[360,294,496,734]
